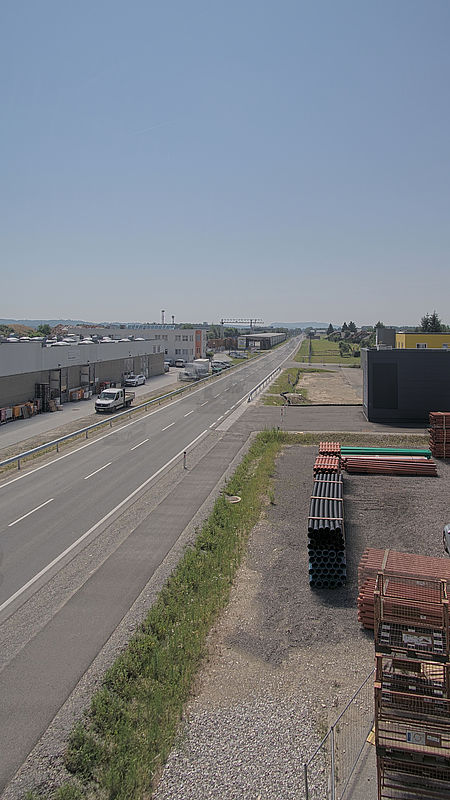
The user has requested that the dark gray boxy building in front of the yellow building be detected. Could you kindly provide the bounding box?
[361,349,450,423]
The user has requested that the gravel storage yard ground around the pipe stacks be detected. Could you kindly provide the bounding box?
[156,446,450,800]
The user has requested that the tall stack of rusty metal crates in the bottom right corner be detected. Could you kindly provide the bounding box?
[374,573,450,800]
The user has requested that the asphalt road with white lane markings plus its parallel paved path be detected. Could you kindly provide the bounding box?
[0,342,293,791]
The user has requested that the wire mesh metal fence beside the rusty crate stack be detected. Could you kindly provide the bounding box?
[304,670,374,800]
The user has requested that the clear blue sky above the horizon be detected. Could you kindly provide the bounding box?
[0,0,450,324]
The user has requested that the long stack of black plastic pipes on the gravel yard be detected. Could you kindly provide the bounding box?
[308,472,346,589]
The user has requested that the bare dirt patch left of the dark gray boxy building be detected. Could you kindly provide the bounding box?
[296,369,362,405]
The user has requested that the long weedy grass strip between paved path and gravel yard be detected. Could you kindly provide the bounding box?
[54,430,286,800]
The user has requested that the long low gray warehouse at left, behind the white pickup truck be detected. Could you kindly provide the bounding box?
[0,340,164,422]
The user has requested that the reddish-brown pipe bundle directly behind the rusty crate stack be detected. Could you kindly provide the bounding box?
[357,548,450,630]
